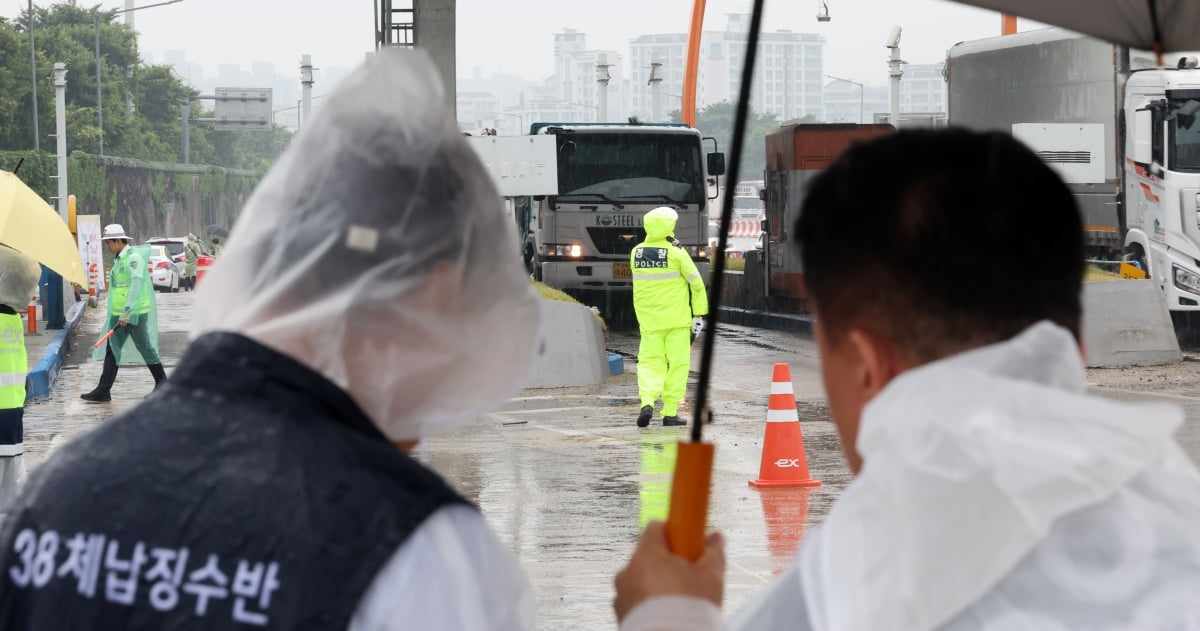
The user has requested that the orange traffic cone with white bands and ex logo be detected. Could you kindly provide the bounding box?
[750,363,821,487]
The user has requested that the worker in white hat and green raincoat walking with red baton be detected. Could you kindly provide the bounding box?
[80,223,167,403]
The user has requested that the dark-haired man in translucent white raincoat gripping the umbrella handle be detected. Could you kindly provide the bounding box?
[616,131,1200,631]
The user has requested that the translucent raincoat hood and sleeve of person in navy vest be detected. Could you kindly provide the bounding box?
[192,50,538,631]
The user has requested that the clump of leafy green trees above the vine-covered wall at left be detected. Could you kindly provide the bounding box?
[0,0,290,169]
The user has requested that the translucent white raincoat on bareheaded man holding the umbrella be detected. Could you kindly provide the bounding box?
[622,323,1200,631]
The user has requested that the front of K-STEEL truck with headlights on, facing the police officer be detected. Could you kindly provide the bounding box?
[515,122,725,314]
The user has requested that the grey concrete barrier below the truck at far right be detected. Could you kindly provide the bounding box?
[1084,281,1183,368]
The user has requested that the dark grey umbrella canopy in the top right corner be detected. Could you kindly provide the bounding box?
[955,0,1200,52]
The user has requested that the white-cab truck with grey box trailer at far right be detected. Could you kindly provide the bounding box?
[946,29,1200,316]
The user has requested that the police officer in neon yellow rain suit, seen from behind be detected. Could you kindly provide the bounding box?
[630,206,708,427]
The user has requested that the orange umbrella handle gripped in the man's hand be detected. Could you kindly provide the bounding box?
[667,443,715,561]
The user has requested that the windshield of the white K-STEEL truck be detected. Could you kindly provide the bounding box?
[558,132,704,204]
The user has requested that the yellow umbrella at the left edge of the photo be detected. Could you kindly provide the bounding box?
[0,170,88,287]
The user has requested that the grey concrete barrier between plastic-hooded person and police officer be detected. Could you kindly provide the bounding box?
[527,300,608,387]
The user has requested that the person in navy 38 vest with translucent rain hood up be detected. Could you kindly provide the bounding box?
[0,50,538,631]
